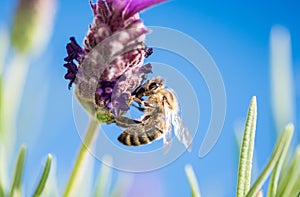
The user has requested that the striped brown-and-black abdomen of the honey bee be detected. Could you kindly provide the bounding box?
[118,118,163,146]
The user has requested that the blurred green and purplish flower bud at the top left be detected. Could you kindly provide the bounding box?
[11,0,56,53]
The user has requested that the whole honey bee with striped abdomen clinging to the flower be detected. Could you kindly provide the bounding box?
[116,77,192,151]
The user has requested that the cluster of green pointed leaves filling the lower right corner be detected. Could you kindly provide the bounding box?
[236,97,300,197]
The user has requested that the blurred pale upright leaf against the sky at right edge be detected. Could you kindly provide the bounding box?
[270,25,296,136]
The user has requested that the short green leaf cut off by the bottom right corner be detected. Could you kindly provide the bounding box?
[276,146,300,197]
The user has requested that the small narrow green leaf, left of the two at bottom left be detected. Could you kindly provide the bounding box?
[9,145,26,197]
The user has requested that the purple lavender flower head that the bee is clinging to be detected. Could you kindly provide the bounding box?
[64,0,164,123]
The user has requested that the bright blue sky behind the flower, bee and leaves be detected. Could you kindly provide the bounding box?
[0,0,300,196]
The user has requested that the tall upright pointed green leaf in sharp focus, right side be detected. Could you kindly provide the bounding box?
[236,96,257,197]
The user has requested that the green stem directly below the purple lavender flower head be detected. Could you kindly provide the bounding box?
[64,119,99,197]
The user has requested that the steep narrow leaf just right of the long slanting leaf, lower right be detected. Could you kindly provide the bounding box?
[268,126,289,197]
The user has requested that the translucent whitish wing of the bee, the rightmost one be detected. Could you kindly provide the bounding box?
[172,113,192,151]
